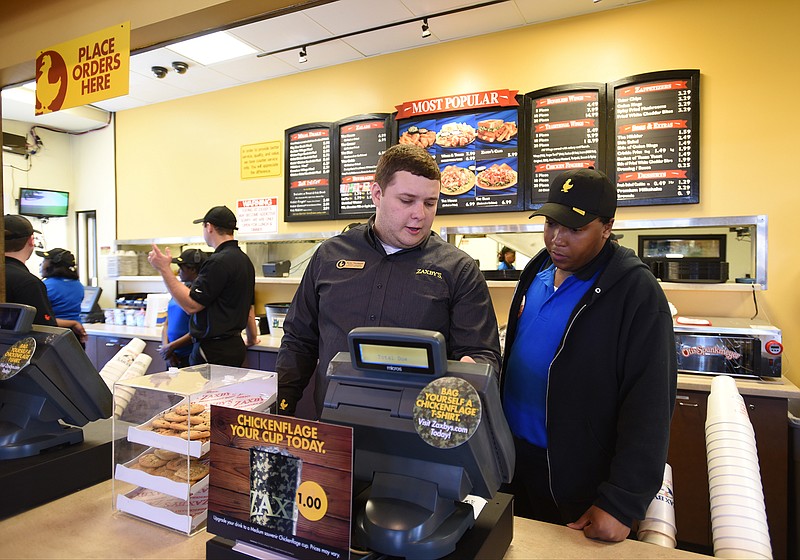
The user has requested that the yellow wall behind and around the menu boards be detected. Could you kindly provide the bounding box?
[117,0,800,383]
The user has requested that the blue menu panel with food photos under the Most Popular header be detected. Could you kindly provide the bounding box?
[397,107,525,214]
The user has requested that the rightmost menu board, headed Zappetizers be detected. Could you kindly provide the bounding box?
[608,70,700,206]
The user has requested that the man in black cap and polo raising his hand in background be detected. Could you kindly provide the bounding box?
[147,206,259,367]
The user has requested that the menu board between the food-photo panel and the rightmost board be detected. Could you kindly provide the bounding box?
[525,84,606,209]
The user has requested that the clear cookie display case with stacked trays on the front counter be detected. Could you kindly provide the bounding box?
[112,364,277,535]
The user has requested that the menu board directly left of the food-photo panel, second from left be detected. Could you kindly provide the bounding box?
[335,113,389,218]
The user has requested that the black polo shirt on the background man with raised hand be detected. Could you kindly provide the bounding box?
[189,239,256,340]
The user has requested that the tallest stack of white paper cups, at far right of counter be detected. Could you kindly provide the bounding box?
[706,375,772,558]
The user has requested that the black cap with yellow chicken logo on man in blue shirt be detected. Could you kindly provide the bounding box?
[530,168,617,228]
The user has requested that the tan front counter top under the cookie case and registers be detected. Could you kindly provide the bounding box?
[0,480,708,560]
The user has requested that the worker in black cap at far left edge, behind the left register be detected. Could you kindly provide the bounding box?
[4,214,87,344]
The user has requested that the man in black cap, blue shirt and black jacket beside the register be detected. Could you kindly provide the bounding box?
[501,169,677,541]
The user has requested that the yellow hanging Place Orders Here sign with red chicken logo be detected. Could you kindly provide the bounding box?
[36,22,131,115]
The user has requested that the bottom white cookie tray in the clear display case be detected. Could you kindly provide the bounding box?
[117,486,208,534]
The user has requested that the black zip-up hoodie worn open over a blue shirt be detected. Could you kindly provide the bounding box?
[501,241,677,527]
